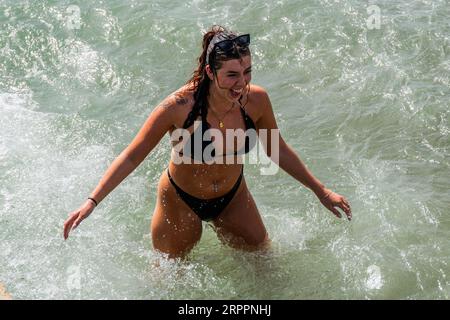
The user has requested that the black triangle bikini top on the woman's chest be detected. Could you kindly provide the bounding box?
[179,107,257,163]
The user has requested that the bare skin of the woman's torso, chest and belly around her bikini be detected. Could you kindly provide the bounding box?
[169,85,261,199]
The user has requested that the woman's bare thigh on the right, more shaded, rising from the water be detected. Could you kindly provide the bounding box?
[213,179,269,250]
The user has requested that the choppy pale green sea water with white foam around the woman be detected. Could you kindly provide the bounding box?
[0,0,450,299]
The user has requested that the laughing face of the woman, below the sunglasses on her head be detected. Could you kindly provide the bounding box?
[207,55,252,102]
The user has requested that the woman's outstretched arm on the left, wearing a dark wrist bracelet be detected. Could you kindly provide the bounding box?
[64,95,176,239]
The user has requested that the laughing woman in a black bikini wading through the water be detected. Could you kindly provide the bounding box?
[64,26,351,258]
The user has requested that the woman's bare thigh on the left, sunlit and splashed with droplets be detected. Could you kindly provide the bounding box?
[151,172,202,258]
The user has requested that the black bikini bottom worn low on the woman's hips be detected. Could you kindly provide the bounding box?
[167,166,244,221]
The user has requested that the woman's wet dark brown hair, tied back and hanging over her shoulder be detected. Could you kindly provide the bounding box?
[183,26,250,128]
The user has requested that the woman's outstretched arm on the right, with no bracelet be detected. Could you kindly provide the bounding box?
[254,87,352,220]
